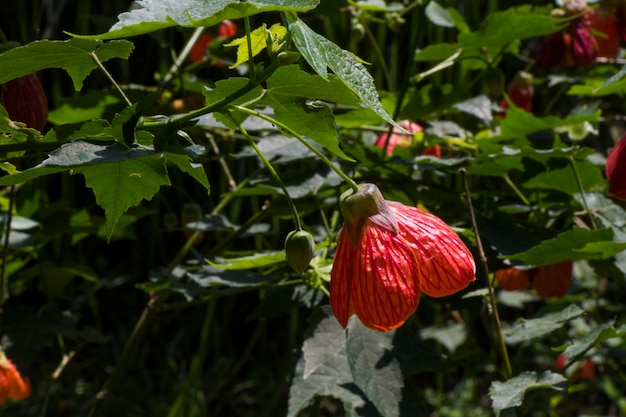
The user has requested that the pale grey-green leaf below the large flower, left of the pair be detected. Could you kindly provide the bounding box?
[287,306,366,417]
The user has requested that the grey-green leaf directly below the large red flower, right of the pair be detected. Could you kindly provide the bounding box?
[346,318,404,417]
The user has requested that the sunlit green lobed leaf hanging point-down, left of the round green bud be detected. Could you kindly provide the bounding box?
[74,151,171,240]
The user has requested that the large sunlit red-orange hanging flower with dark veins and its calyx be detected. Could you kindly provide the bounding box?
[330,184,476,331]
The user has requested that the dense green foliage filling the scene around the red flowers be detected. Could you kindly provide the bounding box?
[0,0,626,417]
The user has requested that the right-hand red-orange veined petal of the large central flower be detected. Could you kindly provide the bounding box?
[387,202,476,297]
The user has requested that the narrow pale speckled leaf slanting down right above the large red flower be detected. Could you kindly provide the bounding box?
[288,15,404,131]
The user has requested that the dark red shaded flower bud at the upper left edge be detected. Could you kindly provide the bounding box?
[0,74,48,131]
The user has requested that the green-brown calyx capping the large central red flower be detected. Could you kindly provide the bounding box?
[339,183,398,246]
